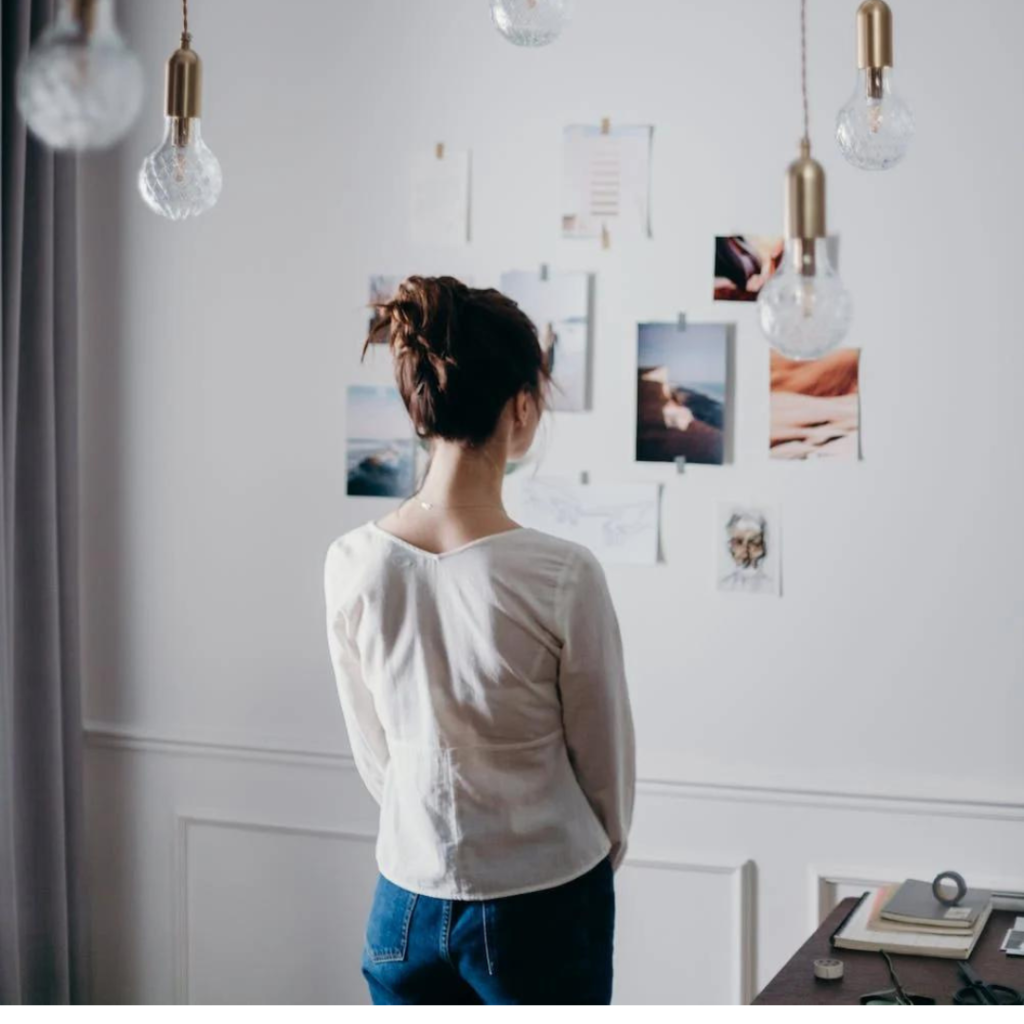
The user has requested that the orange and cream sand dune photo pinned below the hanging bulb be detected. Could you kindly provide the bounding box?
[769,348,860,461]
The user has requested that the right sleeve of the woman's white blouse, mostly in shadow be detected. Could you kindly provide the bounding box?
[558,551,636,868]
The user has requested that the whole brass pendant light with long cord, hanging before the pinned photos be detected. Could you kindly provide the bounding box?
[758,0,853,359]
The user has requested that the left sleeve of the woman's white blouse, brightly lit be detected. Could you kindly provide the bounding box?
[324,548,389,804]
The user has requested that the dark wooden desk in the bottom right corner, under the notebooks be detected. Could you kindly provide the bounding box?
[754,897,1024,1006]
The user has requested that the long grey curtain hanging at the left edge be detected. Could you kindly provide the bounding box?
[0,0,88,1004]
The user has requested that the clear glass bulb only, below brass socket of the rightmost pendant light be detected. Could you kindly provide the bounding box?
[836,68,913,171]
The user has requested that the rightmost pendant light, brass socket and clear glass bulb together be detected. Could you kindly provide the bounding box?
[836,0,913,171]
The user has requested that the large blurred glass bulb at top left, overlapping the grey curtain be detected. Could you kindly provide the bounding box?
[16,0,142,151]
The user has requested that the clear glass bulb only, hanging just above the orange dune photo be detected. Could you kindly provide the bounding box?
[758,239,853,359]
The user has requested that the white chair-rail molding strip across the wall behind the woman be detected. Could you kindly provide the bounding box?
[83,721,1024,822]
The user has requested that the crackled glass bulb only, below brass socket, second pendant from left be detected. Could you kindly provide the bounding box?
[138,118,224,220]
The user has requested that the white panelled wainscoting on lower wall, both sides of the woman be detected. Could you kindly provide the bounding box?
[86,723,1024,1004]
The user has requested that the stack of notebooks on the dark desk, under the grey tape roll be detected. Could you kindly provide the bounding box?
[833,879,992,959]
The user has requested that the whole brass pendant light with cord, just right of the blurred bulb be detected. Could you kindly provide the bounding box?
[138,0,223,220]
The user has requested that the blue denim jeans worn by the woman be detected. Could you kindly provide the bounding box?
[362,857,615,1005]
